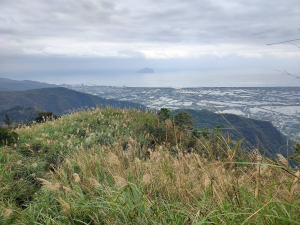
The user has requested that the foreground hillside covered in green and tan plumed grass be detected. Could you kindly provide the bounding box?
[0,108,300,224]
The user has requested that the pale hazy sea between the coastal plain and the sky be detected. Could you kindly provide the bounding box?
[2,70,300,88]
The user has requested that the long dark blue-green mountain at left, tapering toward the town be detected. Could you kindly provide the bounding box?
[0,87,145,115]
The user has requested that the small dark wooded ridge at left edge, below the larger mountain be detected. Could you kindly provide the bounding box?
[0,106,43,125]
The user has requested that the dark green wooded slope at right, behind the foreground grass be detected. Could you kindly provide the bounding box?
[175,109,295,157]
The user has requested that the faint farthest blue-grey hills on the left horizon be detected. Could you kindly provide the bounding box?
[0,78,58,91]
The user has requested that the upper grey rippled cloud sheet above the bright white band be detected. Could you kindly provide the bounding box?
[0,0,300,56]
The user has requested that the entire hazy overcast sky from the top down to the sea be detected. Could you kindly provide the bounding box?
[0,0,300,86]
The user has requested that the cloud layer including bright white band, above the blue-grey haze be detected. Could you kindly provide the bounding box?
[0,0,300,59]
